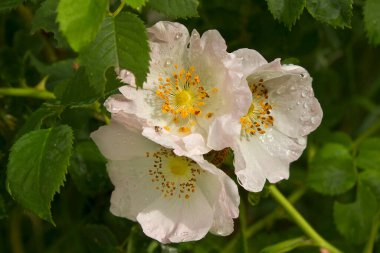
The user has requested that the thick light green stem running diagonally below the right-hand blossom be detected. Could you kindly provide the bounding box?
[269,185,342,253]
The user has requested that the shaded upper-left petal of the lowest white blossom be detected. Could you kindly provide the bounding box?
[91,120,158,160]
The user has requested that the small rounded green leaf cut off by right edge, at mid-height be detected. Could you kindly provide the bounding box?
[356,138,380,171]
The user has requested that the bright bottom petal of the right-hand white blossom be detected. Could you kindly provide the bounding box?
[234,128,306,192]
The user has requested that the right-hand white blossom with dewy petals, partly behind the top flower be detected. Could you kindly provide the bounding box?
[209,49,322,192]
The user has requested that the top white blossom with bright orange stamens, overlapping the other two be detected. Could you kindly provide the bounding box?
[105,22,251,155]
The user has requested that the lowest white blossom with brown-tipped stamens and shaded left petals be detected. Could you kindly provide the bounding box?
[91,114,239,243]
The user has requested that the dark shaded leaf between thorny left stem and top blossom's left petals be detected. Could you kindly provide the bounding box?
[55,68,103,105]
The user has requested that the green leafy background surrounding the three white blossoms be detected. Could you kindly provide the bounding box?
[0,0,380,253]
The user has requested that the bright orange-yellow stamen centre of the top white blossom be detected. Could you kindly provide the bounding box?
[156,64,218,133]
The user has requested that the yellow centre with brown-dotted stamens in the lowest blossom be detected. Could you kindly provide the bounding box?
[146,148,204,199]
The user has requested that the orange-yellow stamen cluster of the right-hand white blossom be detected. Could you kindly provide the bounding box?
[240,79,274,136]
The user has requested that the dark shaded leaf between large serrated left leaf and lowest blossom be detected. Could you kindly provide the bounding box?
[69,141,112,196]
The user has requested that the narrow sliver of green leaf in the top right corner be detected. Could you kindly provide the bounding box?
[363,0,380,45]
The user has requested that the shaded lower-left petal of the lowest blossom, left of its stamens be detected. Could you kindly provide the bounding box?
[107,160,161,220]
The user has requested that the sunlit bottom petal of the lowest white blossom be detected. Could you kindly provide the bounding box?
[137,188,213,243]
